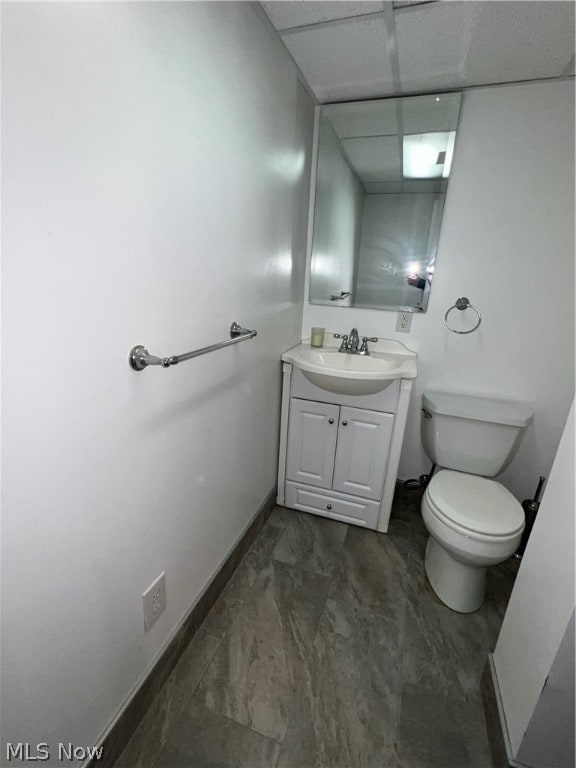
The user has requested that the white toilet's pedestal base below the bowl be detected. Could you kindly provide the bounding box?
[424,536,486,613]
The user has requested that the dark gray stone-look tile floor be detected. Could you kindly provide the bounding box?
[115,485,515,768]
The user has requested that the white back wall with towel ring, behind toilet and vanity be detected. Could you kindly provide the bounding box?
[303,81,574,499]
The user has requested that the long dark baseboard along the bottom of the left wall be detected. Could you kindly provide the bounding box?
[89,488,276,768]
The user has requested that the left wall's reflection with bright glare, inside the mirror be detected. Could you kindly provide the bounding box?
[311,117,364,301]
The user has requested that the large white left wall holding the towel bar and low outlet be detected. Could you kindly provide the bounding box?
[2,3,313,745]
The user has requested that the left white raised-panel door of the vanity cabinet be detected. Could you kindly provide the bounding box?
[286,397,340,488]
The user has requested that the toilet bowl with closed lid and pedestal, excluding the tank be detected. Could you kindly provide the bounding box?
[422,469,524,613]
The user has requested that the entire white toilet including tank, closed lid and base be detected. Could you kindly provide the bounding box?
[422,390,533,613]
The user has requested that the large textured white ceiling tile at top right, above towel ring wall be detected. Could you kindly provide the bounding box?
[395,0,574,92]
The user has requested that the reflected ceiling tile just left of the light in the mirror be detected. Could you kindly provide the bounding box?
[341,136,402,182]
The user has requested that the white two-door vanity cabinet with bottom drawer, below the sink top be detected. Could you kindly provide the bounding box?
[278,362,412,532]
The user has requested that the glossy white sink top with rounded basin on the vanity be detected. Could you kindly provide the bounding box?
[282,334,417,395]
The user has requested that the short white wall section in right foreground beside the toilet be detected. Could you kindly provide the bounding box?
[494,405,575,756]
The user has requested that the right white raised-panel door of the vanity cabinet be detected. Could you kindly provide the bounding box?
[332,406,394,499]
